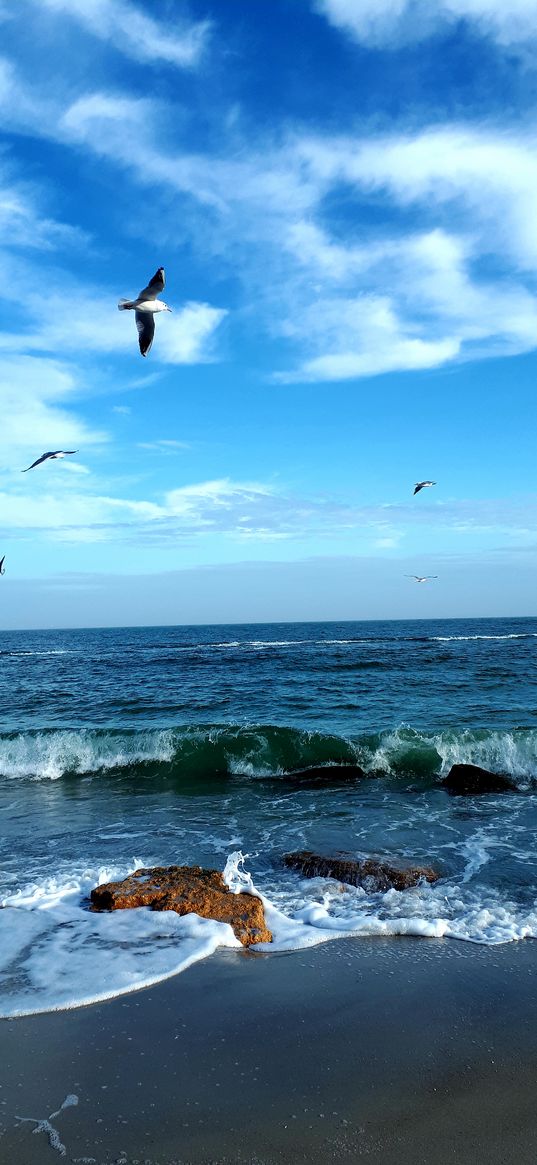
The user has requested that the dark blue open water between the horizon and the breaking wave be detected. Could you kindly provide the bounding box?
[0,619,537,733]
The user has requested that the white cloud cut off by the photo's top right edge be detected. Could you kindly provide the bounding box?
[313,0,537,48]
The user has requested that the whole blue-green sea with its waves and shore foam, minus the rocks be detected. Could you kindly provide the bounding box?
[0,619,537,1017]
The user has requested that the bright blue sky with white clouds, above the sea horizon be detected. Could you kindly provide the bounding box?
[0,0,537,628]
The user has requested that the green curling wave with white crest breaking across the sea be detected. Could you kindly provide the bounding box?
[0,725,537,783]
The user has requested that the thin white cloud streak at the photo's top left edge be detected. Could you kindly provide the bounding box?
[33,0,211,69]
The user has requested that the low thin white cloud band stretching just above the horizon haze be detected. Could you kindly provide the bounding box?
[0,463,537,553]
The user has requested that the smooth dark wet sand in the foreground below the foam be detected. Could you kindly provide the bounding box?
[0,938,537,1165]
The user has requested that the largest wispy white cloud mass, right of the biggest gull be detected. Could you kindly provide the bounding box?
[51,92,537,381]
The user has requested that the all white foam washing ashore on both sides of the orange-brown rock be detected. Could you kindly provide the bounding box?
[0,852,537,1017]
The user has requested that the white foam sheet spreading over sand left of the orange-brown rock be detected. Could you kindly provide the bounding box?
[0,862,240,1017]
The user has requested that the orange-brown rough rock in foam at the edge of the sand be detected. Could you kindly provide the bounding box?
[90,866,273,946]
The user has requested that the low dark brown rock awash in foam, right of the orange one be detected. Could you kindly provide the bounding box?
[283,849,440,890]
